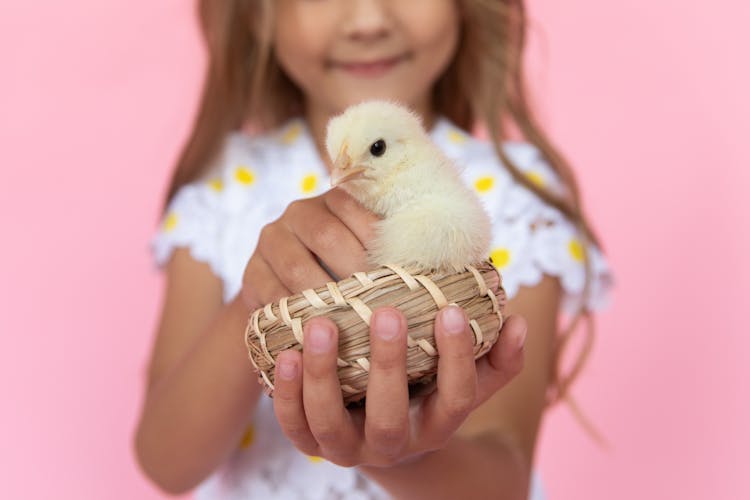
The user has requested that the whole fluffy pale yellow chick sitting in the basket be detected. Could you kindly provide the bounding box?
[326,101,491,272]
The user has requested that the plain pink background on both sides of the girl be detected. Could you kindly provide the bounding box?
[0,0,750,499]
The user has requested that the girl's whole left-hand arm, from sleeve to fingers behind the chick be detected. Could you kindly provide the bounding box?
[135,189,378,493]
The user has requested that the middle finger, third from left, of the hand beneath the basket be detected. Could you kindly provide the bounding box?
[365,308,409,458]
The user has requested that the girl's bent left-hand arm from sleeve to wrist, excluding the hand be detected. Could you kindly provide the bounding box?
[135,249,261,493]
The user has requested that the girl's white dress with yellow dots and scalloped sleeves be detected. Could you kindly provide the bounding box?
[152,119,611,500]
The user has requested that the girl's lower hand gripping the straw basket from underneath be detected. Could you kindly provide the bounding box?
[273,306,526,467]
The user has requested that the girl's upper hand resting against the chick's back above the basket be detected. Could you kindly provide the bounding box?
[242,188,378,310]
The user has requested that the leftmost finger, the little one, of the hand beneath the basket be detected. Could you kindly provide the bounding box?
[273,349,320,455]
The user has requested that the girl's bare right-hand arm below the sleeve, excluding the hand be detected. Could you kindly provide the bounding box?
[360,276,561,499]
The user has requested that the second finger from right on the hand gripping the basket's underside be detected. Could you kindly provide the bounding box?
[423,305,477,437]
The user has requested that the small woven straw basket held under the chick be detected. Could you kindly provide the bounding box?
[245,262,505,403]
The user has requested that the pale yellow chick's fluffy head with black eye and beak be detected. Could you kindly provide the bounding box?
[326,101,425,196]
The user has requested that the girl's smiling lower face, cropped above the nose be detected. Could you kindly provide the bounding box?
[273,0,459,119]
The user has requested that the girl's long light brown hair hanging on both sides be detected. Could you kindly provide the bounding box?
[167,0,597,422]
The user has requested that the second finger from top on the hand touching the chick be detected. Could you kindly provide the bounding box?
[288,207,367,278]
